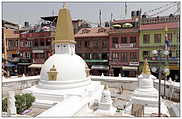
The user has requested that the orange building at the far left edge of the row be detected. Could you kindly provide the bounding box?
[2,20,19,76]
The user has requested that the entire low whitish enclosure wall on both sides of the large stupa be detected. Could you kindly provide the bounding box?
[2,75,180,102]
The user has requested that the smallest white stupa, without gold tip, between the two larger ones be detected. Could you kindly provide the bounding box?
[95,84,116,116]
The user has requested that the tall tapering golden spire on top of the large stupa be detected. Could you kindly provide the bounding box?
[55,3,76,43]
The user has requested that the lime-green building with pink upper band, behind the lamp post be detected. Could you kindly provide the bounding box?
[140,16,180,81]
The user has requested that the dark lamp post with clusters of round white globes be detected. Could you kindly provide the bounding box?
[151,50,169,117]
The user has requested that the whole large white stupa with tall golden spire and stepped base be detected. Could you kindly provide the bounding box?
[24,3,104,117]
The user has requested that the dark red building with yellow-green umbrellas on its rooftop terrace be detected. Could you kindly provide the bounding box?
[109,11,140,76]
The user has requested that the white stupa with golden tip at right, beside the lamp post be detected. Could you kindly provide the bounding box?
[125,59,169,117]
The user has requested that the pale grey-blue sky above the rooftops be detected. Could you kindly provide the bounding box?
[2,2,180,25]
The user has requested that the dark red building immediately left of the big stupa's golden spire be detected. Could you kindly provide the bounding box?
[29,31,54,75]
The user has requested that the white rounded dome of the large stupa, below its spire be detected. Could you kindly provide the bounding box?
[39,54,90,89]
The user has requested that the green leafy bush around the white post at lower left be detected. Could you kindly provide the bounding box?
[3,94,35,114]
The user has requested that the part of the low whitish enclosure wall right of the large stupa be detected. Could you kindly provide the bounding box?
[90,76,180,102]
